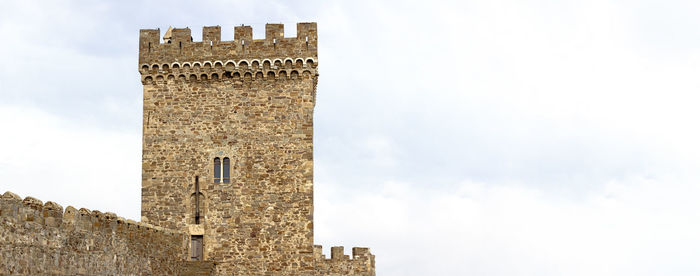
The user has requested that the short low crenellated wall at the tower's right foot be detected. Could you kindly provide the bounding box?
[314,245,376,276]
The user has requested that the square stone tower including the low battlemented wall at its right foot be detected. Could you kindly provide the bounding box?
[139,23,374,275]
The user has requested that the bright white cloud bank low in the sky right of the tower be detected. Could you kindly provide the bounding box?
[315,176,700,275]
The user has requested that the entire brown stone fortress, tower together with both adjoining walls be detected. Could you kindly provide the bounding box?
[0,23,375,275]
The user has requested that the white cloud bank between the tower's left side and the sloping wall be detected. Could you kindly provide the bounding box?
[0,106,141,220]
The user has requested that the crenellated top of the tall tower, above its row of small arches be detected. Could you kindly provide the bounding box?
[139,22,318,69]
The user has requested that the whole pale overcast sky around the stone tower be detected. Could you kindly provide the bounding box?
[0,0,700,276]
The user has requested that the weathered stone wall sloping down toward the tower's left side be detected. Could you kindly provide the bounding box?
[0,192,187,275]
